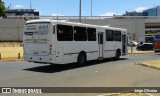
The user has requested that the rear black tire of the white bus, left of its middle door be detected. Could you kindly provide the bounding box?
[77,52,87,66]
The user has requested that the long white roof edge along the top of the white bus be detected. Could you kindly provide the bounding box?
[26,19,127,31]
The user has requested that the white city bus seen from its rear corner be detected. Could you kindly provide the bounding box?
[23,20,128,65]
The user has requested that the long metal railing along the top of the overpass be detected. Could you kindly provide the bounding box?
[6,16,160,20]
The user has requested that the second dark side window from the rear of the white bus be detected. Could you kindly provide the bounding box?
[74,26,87,41]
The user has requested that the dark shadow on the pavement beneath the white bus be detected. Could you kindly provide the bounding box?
[23,58,126,73]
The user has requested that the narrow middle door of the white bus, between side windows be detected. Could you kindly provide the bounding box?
[98,32,104,59]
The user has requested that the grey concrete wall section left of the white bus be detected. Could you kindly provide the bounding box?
[0,19,25,41]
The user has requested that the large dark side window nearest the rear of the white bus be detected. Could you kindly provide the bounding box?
[57,25,73,41]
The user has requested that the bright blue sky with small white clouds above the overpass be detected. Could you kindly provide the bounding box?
[2,0,160,16]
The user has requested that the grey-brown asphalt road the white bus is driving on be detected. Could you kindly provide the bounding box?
[0,53,160,96]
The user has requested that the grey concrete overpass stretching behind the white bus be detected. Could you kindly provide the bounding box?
[0,16,160,42]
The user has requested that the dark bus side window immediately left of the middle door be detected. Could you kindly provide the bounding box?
[87,28,96,41]
